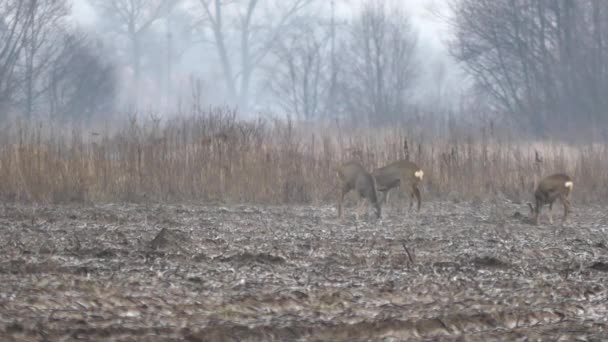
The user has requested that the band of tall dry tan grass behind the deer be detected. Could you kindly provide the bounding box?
[0,110,608,204]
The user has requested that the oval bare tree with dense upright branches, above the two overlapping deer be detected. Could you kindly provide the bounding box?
[339,1,417,124]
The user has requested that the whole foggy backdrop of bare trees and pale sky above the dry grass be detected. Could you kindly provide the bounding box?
[0,0,608,134]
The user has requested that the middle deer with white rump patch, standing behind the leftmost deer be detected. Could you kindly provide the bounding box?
[372,160,424,211]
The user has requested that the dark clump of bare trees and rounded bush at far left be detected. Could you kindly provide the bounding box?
[0,0,116,120]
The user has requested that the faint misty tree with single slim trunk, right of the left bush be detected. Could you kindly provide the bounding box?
[90,0,179,107]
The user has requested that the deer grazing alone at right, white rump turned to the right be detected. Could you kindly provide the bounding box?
[528,173,574,225]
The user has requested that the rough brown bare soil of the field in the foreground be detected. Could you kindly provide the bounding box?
[0,201,608,341]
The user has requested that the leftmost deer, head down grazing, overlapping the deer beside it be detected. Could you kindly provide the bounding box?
[337,161,381,218]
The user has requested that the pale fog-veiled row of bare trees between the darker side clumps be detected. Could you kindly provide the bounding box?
[84,0,428,125]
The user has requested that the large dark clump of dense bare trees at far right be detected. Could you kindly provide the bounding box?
[451,0,608,137]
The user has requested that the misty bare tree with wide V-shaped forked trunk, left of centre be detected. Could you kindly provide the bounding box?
[199,0,314,111]
